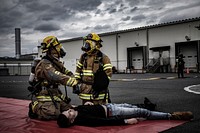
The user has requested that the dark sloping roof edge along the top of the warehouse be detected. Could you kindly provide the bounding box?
[60,17,200,43]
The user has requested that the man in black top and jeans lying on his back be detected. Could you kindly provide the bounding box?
[57,102,193,128]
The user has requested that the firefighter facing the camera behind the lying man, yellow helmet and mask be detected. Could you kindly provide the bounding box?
[74,33,112,104]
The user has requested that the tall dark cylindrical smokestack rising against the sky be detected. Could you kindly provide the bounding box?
[15,28,21,59]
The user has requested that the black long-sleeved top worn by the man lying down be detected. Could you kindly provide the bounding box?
[74,105,125,127]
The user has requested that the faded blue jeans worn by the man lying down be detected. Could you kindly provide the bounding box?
[105,103,171,120]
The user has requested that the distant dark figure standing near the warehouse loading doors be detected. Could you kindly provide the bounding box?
[177,54,185,78]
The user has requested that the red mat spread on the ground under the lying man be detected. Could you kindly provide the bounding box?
[0,97,186,133]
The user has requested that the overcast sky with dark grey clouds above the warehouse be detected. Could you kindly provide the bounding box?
[0,0,200,57]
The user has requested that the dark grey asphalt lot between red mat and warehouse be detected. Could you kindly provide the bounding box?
[0,73,200,133]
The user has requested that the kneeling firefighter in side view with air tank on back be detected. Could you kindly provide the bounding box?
[28,36,78,120]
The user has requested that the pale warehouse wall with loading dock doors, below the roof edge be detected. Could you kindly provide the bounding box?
[47,17,200,73]
